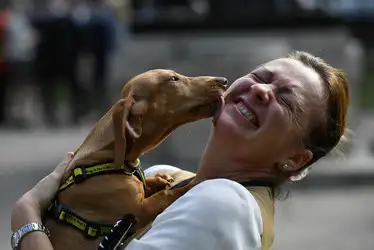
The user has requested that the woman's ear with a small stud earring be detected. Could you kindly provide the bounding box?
[280,149,313,173]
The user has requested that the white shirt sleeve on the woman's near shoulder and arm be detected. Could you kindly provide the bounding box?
[126,179,262,250]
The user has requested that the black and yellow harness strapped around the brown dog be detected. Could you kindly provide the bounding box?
[48,159,146,239]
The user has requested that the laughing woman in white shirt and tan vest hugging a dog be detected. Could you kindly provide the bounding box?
[12,52,349,250]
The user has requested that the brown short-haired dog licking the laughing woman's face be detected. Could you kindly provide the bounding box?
[43,70,227,250]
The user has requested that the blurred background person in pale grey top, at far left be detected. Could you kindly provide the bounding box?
[2,2,35,127]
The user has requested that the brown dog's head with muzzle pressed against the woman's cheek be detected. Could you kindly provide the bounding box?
[112,69,227,162]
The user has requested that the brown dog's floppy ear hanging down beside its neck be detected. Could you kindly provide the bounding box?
[112,97,145,168]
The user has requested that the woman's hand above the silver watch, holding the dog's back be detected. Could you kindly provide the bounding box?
[11,152,74,231]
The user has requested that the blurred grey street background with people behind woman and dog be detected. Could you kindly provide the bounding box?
[0,0,374,250]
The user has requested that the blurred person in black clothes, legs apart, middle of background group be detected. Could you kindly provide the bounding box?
[33,0,87,126]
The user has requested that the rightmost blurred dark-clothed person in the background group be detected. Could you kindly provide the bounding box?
[71,0,119,117]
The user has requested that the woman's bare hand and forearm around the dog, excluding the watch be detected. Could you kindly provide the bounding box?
[11,153,73,250]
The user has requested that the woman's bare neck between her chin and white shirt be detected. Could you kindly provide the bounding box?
[195,136,275,181]
